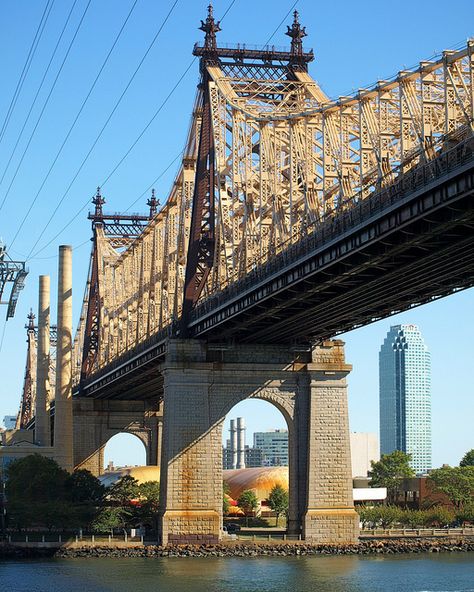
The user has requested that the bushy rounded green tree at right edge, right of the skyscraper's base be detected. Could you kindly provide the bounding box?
[428,466,474,510]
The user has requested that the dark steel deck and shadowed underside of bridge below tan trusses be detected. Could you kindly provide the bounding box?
[76,138,474,398]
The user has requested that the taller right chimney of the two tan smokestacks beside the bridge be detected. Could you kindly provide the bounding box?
[54,245,74,471]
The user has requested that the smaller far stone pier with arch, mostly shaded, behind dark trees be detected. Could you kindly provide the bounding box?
[73,397,163,476]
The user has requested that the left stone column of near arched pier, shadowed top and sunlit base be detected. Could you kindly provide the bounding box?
[160,340,222,545]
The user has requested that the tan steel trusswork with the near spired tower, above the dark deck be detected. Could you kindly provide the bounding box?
[76,10,474,388]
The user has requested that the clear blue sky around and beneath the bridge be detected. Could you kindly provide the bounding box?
[0,0,474,465]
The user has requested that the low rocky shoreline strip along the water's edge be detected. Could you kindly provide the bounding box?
[0,539,474,559]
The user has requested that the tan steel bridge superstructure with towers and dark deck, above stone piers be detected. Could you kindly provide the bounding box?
[35,10,474,399]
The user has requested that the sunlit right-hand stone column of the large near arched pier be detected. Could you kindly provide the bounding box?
[299,341,359,543]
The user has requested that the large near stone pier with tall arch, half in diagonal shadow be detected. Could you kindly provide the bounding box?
[160,340,358,544]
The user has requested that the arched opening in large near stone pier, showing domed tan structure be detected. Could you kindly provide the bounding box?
[222,397,293,529]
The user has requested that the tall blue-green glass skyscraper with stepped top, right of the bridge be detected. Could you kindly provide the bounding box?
[379,325,431,473]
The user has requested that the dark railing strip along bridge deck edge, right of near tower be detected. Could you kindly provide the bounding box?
[191,131,474,322]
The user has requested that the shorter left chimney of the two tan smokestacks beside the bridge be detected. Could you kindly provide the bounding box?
[35,275,51,446]
